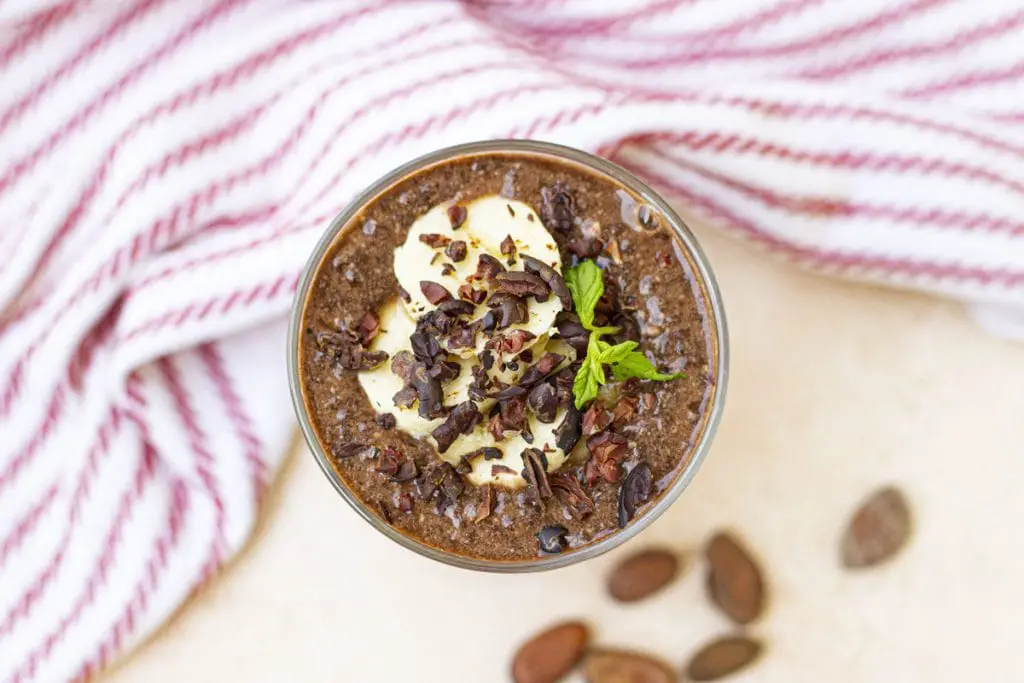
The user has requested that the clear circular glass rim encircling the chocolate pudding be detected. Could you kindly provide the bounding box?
[288,139,729,573]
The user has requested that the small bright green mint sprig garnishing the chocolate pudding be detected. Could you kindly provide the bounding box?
[564,260,685,410]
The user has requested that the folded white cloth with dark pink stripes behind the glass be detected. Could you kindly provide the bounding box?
[0,0,1024,683]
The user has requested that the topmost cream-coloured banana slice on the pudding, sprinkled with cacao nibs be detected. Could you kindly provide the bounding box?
[394,196,562,357]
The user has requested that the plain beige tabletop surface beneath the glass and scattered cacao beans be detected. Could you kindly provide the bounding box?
[108,215,1024,683]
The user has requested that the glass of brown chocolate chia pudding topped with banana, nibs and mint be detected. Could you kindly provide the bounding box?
[292,142,725,565]
